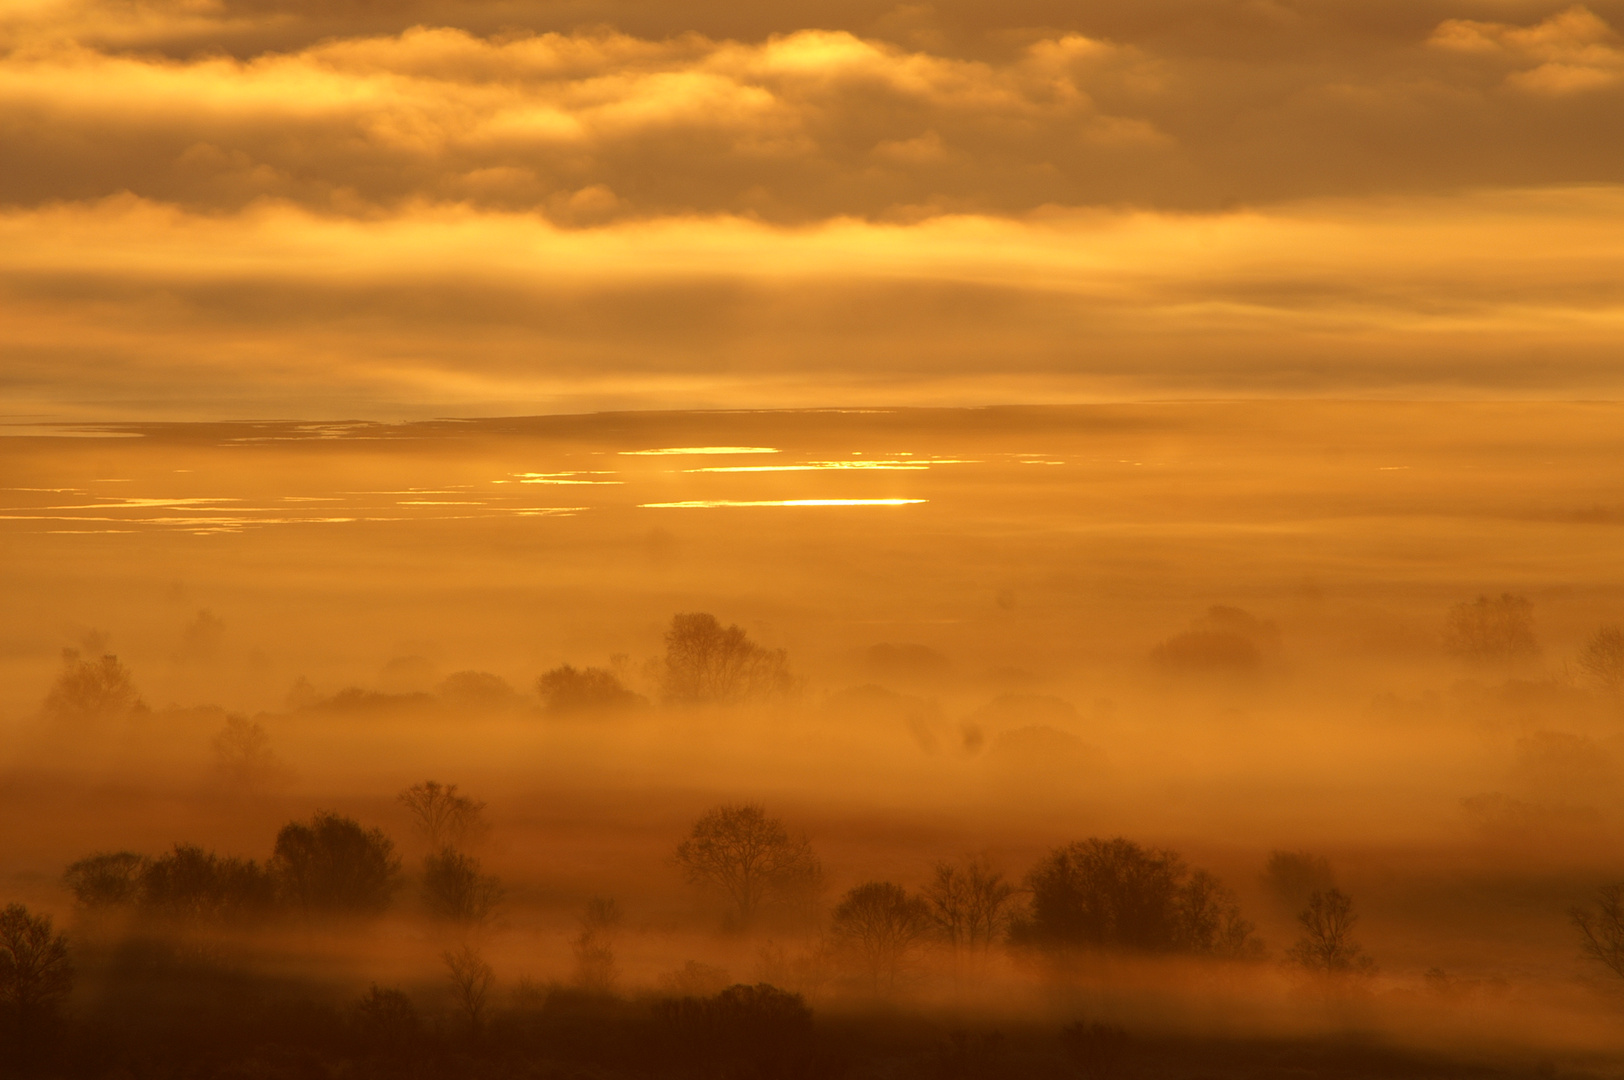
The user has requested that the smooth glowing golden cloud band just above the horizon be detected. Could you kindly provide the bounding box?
[0,187,1624,414]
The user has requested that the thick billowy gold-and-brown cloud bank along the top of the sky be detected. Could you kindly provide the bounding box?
[0,3,1624,217]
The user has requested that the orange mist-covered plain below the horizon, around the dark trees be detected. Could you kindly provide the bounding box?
[0,403,1624,1075]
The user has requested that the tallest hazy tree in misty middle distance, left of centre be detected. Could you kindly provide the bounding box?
[661,612,794,705]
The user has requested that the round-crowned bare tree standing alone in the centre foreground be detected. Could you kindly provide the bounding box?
[676,802,823,927]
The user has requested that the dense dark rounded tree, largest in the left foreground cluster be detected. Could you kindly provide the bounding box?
[271,812,400,914]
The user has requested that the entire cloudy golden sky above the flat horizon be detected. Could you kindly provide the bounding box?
[0,0,1624,422]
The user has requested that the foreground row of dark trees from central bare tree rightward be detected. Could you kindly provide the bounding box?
[676,804,1371,989]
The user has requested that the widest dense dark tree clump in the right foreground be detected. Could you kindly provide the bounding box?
[1012,836,1255,957]
